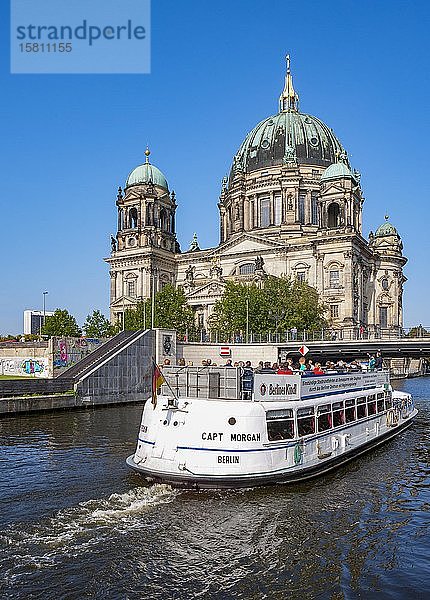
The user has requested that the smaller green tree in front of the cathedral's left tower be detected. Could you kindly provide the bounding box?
[125,284,195,335]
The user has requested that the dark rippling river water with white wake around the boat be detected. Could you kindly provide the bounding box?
[0,378,430,600]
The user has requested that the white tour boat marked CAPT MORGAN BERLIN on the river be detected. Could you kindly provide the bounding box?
[127,367,417,488]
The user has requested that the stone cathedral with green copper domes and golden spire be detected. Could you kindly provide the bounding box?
[105,57,407,331]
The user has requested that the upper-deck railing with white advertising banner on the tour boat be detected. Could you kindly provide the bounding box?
[162,365,390,402]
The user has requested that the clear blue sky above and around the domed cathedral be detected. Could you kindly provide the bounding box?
[0,0,430,334]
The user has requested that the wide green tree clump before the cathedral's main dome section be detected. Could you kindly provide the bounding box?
[210,277,325,336]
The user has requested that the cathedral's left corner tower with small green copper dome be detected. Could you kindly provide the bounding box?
[106,148,180,322]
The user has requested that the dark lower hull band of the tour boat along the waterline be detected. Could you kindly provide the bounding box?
[126,410,417,489]
